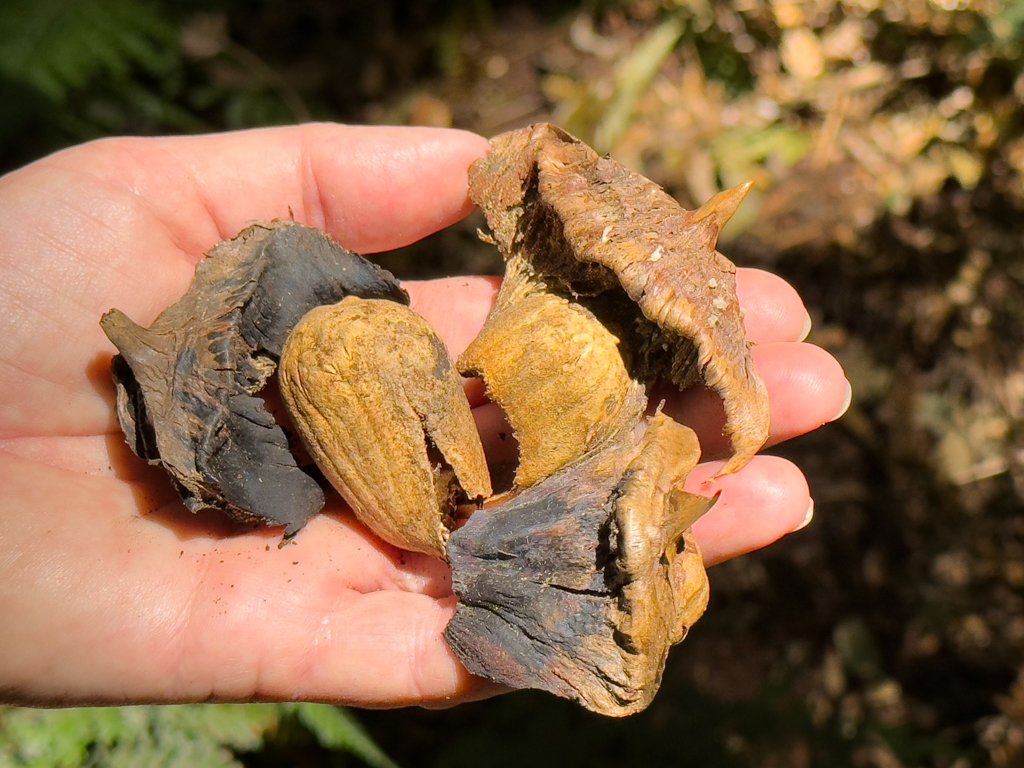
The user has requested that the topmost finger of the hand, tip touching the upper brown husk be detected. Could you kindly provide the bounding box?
[54,124,487,257]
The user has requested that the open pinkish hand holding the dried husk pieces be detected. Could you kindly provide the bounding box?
[0,125,849,707]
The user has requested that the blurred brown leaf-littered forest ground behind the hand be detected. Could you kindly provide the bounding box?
[0,0,1024,768]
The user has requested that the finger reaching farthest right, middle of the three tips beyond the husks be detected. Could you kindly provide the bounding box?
[651,343,851,459]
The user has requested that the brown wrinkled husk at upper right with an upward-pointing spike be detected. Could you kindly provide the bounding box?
[470,124,769,472]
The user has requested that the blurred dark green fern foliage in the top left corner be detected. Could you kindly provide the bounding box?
[0,0,206,167]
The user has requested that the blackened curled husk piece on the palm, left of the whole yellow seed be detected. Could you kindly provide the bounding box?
[101,221,409,534]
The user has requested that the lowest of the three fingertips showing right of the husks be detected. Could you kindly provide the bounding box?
[686,456,813,565]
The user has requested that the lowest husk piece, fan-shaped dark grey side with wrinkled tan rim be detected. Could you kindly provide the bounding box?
[445,414,714,716]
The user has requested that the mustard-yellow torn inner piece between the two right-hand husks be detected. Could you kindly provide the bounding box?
[459,293,647,487]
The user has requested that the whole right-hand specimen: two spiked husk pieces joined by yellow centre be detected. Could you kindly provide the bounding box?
[445,125,768,715]
